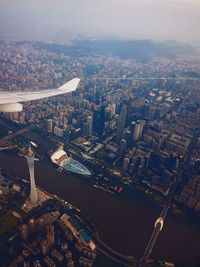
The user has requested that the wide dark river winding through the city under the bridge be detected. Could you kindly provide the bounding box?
[0,153,200,267]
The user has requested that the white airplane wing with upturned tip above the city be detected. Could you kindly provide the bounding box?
[0,78,80,112]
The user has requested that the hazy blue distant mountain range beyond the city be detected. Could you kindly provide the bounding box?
[28,40,198,63]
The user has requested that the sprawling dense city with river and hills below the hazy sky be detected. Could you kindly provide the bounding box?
[0,1,200,267]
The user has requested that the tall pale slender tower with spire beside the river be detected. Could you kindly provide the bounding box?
[26,143,38,204]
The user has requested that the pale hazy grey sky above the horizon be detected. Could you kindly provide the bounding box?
[0,0,200,42]
